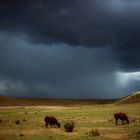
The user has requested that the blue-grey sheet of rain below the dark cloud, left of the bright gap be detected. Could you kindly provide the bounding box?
[0,32,121,98]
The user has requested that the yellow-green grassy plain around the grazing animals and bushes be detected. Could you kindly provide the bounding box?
[0,103,140,140]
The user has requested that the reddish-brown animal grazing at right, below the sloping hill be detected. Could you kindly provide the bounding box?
[114,112,129,125]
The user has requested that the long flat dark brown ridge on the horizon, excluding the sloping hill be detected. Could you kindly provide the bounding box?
[0,96,116,106]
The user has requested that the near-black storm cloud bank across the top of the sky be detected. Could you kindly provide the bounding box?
[0,0,140,70]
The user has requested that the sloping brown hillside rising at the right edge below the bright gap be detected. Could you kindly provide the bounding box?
[117,91,140,104]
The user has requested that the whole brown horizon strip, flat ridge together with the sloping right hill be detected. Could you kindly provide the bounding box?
[0,91,140,106]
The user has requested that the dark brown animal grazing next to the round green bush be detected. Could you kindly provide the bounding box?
[44,116,60,128]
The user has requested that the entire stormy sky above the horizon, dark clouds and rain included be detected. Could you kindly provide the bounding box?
[0,0,140,99]
